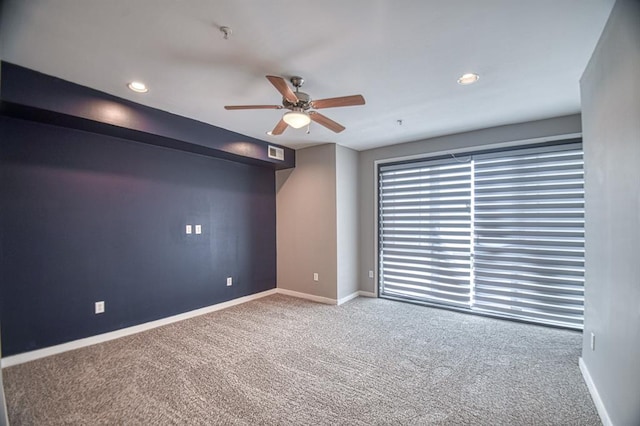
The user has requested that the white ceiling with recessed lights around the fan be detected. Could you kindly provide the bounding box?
[0,0,614,150]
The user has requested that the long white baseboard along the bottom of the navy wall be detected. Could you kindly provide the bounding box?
[0,288,278,368]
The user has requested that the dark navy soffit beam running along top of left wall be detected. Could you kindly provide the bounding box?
[0,62,295,170]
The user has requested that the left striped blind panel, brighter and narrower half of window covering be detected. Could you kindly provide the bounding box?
[378,156,471,307]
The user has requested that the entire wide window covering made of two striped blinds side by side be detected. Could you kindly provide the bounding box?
[379,143,584,329]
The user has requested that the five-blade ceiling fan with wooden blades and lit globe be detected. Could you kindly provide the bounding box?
[224,75,364,135]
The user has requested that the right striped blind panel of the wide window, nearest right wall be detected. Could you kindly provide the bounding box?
[472,145,584,328]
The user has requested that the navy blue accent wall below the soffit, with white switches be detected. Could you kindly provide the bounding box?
[0,116,276,356]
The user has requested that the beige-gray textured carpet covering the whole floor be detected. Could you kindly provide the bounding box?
[3,295,600,425]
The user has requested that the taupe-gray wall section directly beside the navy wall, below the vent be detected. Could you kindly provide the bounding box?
[276,144,337,299]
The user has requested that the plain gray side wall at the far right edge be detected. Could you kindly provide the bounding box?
[581,0,640,425]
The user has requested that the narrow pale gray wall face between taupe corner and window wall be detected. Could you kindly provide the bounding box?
[336,145,358,299]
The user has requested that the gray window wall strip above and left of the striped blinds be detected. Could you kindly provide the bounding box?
[358,113,581,292]
